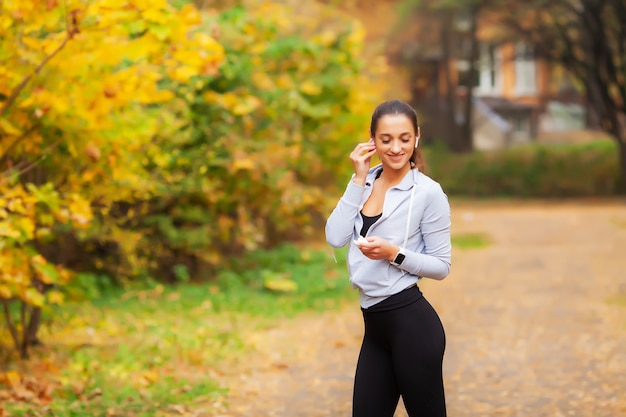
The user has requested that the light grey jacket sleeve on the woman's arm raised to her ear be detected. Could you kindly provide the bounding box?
[326,180,366,248]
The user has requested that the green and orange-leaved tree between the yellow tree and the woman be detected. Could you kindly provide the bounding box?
[114,3,377,280]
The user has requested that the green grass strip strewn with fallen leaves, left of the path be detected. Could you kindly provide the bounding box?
[0,245,356,417]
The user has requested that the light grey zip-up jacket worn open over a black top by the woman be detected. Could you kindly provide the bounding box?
[326,165,452,308]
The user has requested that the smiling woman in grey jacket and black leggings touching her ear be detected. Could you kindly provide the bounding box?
[326,100,451,417]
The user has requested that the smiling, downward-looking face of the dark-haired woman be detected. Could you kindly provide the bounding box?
[374,114,419,169]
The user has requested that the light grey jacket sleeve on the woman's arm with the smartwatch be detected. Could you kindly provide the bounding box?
[402,183,452,280]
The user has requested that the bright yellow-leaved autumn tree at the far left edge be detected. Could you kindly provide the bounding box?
[0,0,223,357]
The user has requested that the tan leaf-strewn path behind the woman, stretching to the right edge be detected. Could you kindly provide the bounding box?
[208,201,626,417]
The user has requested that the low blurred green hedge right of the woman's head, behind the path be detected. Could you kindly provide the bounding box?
[426,140,619,197]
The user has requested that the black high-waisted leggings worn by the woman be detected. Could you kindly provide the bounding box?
[352,286,446,417]
